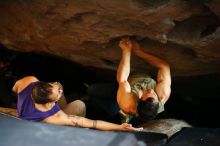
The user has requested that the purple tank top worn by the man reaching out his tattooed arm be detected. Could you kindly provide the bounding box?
[17,82,60,121]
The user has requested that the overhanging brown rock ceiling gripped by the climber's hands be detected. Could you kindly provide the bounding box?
[0,0,220,76]
